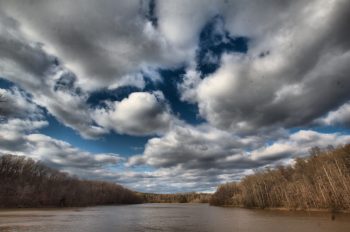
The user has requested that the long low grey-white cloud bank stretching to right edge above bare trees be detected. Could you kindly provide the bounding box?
[128,124,322,170]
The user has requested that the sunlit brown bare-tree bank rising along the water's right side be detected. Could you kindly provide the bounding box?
[210,144,350,210]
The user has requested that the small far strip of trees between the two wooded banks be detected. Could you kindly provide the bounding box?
[139,192,211,203]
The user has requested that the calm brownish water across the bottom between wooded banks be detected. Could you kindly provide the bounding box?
[0,204,350,232]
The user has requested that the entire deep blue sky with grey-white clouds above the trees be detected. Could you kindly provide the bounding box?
[0,0,350,193]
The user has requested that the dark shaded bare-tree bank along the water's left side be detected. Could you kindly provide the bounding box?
[0,155,142,207]
